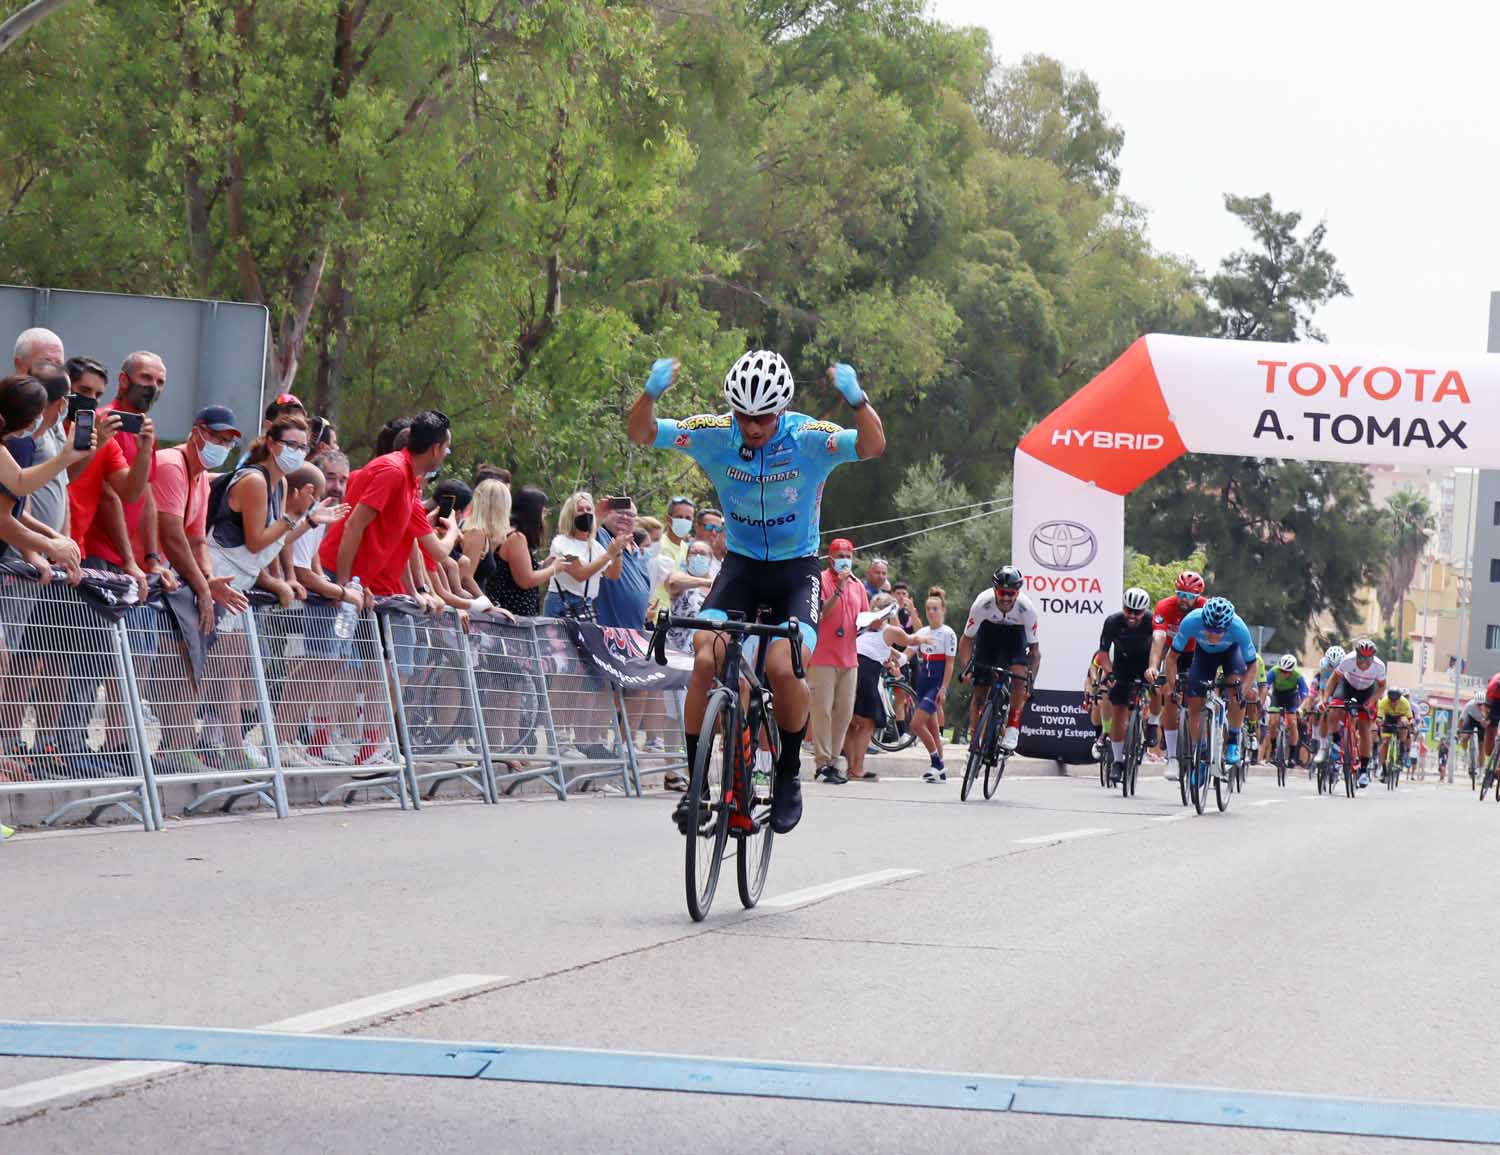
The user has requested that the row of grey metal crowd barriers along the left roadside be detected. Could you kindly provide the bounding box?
[0,569,684,830]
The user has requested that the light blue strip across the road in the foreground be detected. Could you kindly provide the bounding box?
[0,1022,1500,1143]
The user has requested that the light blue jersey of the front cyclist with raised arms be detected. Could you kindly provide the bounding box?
[654,413,860,561]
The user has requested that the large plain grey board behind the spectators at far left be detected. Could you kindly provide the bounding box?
[0,285,269,441]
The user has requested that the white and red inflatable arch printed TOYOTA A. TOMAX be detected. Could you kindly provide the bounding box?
[1011,333,1500,762]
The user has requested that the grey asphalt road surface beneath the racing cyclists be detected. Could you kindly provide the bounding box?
[0,759,1500,1152]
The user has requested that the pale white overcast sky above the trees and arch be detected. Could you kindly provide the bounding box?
[932,0,1500,353]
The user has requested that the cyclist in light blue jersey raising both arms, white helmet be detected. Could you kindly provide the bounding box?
[627,350,885,834]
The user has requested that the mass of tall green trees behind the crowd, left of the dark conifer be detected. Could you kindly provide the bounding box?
[0,0,1230,531]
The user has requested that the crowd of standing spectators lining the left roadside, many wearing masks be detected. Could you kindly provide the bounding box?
[0,329,951,789]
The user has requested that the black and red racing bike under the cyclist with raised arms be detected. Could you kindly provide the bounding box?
[651,609,803,923]
